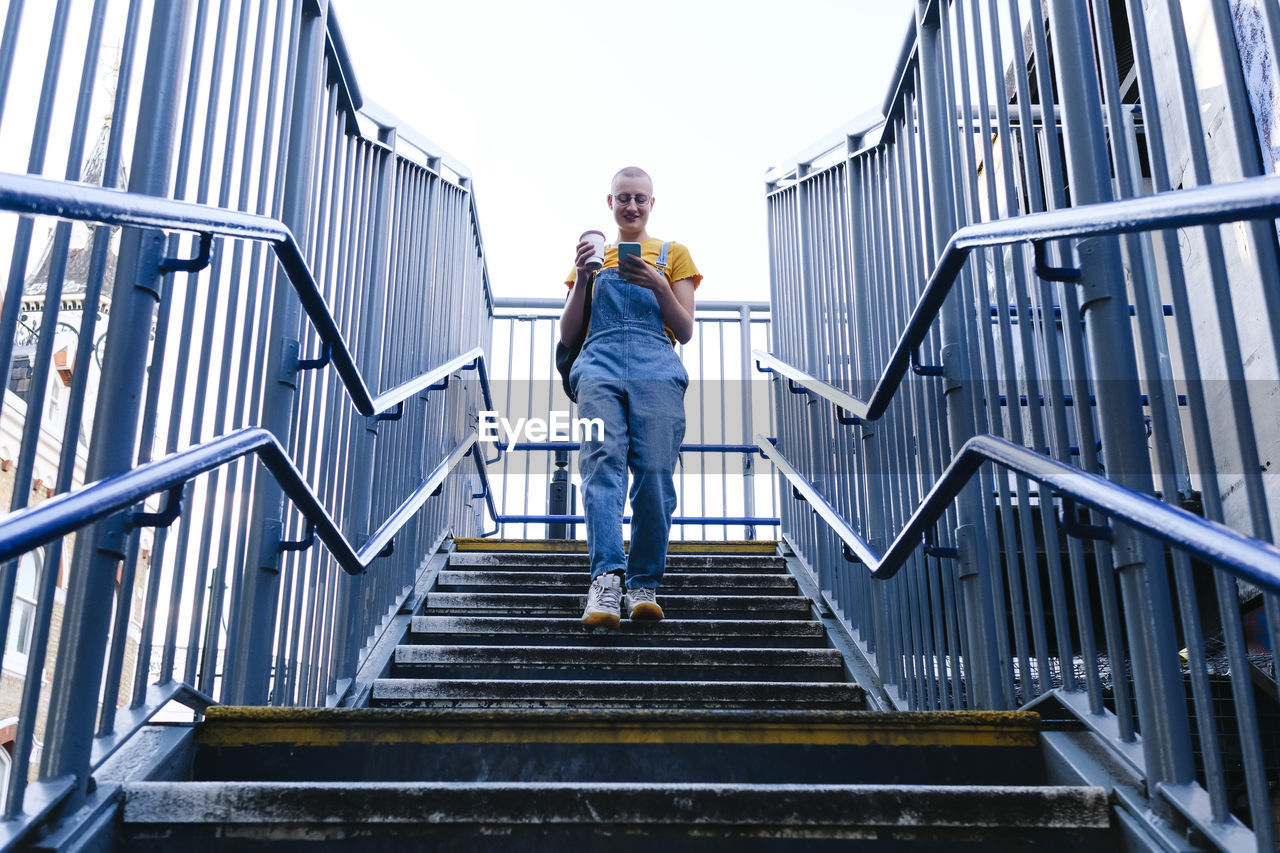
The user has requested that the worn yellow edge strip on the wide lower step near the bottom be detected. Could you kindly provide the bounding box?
[197,708,1039,748]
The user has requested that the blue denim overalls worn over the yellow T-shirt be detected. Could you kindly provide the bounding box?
[570,243,689,589]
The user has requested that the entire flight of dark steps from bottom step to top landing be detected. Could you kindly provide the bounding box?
[112,540,1117,852]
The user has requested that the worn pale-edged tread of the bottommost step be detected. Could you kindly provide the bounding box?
[123,781,1111,830]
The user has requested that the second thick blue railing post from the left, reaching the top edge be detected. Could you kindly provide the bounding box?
[225,0,329,704]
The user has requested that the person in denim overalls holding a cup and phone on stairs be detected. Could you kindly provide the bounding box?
[561,167,703,628]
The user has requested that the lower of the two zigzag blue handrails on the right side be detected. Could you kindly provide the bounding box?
[755,435,1280,592]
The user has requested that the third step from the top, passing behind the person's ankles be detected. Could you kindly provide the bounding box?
[435,570,799,596]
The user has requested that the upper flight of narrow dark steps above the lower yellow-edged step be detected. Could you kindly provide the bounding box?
[371,543,863,711]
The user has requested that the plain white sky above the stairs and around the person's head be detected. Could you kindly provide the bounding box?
[333,0,914,300]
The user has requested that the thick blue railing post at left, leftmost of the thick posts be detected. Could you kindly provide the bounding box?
[41,0,191,815]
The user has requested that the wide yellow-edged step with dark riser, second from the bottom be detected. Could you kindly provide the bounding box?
[193,706,1046,785]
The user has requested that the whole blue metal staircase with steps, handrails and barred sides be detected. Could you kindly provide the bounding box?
[0,0,1280,852]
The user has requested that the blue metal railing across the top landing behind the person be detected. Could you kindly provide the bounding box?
[489,294,778,540]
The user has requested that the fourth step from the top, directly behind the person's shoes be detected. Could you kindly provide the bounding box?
[424,589,810,619]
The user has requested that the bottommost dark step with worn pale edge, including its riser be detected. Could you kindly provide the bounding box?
[122,783,1110,853]
